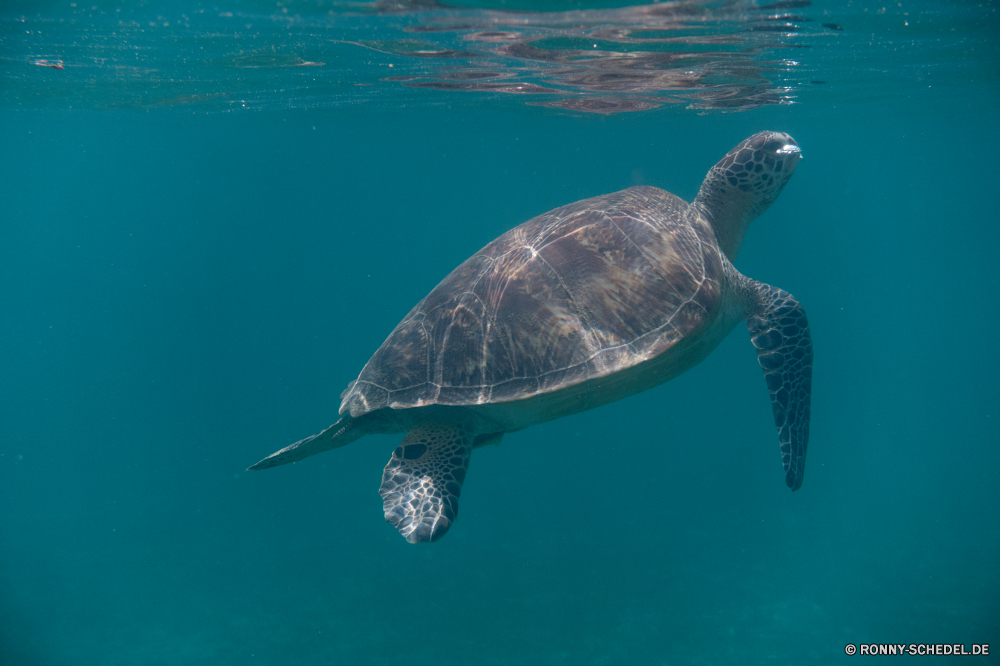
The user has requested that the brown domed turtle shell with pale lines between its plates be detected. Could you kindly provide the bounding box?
[340,187,723,418]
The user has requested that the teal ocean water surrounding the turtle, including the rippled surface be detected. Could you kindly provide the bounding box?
[0,0,1000,666]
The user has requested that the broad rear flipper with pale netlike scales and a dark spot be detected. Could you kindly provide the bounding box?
[378,422,476,543]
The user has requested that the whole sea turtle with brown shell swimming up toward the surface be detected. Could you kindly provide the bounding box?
[250,132,812,542]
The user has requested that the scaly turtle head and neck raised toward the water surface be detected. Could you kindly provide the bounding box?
[694,132,802,261]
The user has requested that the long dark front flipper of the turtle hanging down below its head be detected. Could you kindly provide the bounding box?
[747,282,812,490]
